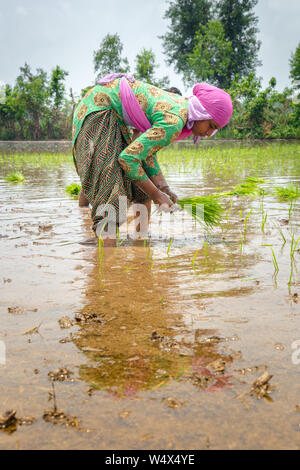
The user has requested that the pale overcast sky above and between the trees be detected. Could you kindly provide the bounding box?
[0,0,300,97]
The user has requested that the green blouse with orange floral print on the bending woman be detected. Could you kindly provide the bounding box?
[73,78,188,181]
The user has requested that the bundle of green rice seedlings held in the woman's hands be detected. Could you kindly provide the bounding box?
[178,196,224,228]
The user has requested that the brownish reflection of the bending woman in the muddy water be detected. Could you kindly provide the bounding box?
[74,247,232,396]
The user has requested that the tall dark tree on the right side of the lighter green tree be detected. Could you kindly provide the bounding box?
[217,0,261,86]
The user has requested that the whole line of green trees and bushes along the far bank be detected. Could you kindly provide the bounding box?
[0,0,300,140]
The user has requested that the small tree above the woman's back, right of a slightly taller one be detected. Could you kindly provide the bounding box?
[135,48,170,88]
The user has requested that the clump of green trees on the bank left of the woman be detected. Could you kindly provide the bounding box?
[0,63,72,140]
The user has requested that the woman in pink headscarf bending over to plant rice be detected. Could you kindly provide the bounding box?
[73,74,232,242]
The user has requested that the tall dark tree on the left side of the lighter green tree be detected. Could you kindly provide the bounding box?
[160,0,212,73]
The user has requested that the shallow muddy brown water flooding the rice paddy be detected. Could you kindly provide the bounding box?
[0,145,300,449]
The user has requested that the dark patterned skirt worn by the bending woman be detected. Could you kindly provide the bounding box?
[74,110,149,232]
